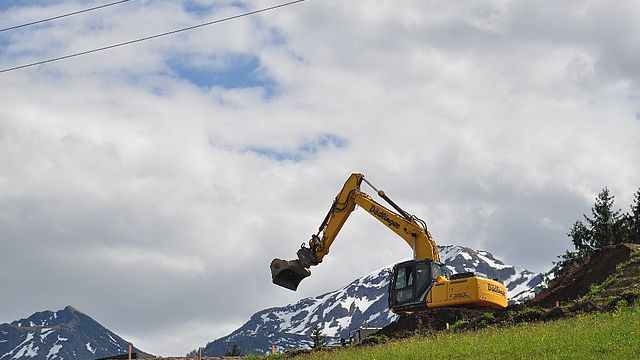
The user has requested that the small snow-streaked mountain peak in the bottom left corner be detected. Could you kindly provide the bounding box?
[0,306,144,360]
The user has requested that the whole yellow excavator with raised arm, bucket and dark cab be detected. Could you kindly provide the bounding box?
[270,173,507,313]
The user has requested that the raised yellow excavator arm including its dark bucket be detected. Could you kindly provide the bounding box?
[271,173,440,290]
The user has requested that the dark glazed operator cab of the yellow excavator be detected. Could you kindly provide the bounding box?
[389,260,446,313]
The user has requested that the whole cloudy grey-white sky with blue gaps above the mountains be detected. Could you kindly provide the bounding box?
[0,0,640,355]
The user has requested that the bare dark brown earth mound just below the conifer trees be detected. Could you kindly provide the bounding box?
[527,244,640,306]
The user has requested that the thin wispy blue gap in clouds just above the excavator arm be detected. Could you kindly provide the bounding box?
[247,134,349,162]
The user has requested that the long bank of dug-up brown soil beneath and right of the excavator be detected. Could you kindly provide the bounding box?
[370,244,640,343]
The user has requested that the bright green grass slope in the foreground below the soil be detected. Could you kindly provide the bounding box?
[278,306,640,360]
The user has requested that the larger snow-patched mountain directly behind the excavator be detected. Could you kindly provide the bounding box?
[200,245,544,360]
